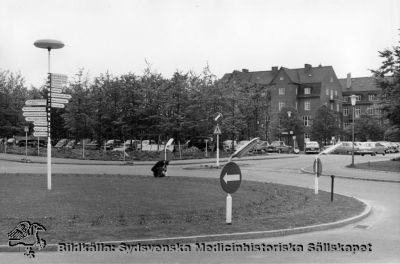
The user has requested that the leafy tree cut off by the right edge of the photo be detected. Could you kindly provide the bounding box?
[372,43,400,136]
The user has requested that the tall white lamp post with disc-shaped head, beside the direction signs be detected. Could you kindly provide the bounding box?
[33,39,64,190]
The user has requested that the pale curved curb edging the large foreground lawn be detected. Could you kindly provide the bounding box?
[0,197,372,252]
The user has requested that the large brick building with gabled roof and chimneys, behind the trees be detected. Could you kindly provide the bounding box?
[221,64,343,149]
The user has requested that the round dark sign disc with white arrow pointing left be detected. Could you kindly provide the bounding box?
[220,162,242,193]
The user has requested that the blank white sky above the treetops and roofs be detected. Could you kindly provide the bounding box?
[0,0,400,87]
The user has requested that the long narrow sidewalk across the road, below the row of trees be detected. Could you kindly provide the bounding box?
[0,153,299,166]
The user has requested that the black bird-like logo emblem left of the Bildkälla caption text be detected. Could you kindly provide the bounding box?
[8,221,46,258]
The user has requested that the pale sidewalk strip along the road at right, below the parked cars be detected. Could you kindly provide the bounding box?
[301,164,400,183]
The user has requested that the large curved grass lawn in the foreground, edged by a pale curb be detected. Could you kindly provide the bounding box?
[0,174,364,244]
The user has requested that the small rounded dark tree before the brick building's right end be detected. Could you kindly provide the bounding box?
[311,105,339,145]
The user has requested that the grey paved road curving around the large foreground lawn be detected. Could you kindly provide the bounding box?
[0,155,400,263]
